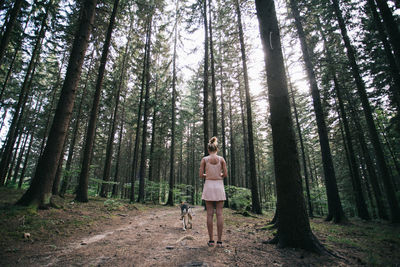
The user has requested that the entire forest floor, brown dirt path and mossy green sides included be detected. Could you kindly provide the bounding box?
[0,188,400,266]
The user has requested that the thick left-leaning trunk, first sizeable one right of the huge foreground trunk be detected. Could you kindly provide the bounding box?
[290,0,346,223]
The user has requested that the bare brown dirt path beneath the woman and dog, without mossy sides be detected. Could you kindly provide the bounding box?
[3,207,345,266]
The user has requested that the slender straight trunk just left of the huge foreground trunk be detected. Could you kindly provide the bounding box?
[236,0,262,214]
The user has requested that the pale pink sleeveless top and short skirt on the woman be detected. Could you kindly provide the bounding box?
[201,156,226,201]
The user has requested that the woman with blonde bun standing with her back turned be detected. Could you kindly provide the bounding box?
[199,137,228,247]
